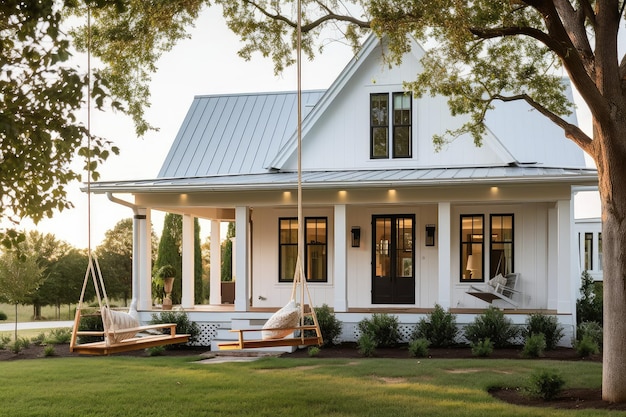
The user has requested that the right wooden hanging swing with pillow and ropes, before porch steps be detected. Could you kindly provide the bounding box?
[218,0,324,350]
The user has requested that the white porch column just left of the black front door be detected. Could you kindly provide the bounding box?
[333,204,348,312]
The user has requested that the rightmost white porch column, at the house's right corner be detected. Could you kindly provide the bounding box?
[557,200,576,312]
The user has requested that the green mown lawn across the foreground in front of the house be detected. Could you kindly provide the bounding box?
[0,356,626,417]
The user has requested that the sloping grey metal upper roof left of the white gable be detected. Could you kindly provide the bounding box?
[158,90,325,178]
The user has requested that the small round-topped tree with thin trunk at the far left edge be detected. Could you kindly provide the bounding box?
[0,250,44,340]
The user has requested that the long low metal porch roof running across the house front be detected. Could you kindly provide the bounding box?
[91,166,597,193]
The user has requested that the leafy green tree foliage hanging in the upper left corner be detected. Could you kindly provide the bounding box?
[0,0,118,247]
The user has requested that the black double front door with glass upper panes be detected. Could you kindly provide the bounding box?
[372,215,415,304]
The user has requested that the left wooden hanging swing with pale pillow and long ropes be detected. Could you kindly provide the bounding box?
[70,9,190,355]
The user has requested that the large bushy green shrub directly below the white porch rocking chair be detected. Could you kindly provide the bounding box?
[465,307,519,348]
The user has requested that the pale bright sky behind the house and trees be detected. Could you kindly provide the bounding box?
[21,7,600,248]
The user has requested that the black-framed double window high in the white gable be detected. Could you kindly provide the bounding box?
[370,92,413,159]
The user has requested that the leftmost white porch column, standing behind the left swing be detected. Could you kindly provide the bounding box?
[129,208,152,318]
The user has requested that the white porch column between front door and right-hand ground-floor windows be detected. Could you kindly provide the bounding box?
[433,202,452,310]
